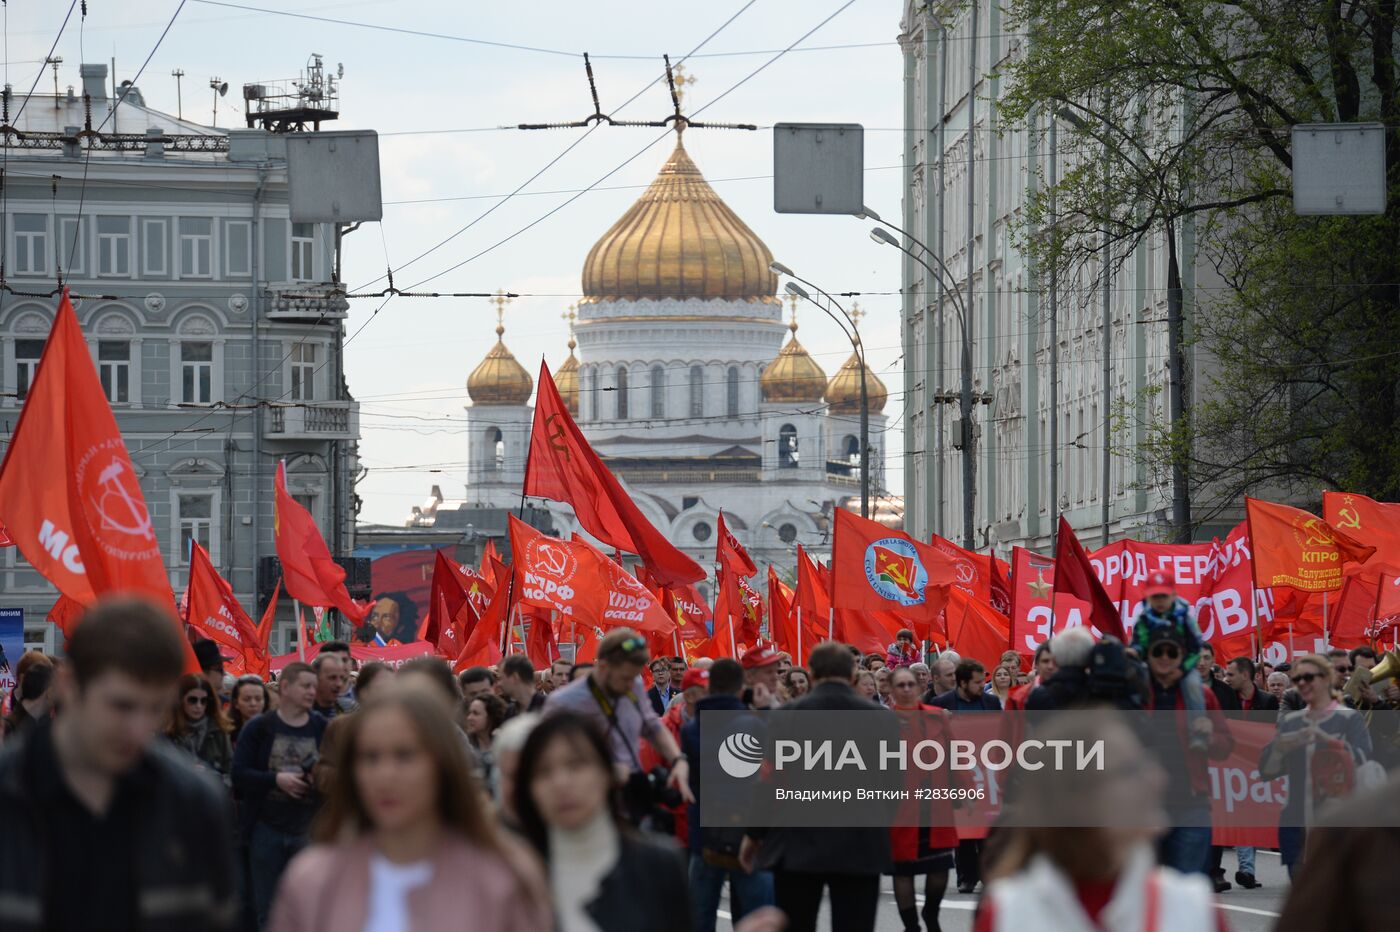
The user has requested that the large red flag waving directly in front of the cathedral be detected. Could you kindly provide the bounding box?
[525,361,704,586]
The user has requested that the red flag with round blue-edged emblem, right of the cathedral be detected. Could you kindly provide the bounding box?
[832,508,958,615]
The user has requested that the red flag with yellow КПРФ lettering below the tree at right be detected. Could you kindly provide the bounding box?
[1245,498,1376,592]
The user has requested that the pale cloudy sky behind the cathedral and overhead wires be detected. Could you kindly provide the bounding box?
[6,0,903,523]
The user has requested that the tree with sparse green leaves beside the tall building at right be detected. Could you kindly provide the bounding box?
[1000,0,1400,525]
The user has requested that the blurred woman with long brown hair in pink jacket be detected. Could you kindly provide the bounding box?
[269,689,553,932]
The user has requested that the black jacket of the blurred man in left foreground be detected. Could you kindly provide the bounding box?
[0,725,238,932]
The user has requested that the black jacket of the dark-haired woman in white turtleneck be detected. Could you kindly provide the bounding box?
[584,831,694,932]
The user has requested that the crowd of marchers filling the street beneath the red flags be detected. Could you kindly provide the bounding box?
[0,579,1400,932]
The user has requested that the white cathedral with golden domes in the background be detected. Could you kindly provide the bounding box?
[448,133,888,571]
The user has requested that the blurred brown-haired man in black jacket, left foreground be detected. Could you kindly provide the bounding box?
[0,600,237,932]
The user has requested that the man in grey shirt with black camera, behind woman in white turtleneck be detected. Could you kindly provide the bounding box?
[545,628,694,824]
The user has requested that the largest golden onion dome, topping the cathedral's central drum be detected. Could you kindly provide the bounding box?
[584,136,778,302]
